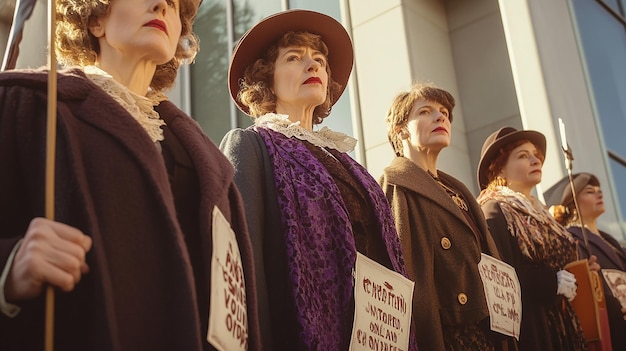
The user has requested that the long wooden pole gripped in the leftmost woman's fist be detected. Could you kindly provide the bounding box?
[45,0,57,351]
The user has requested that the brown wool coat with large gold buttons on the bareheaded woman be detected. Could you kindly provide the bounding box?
[379,157,498,350]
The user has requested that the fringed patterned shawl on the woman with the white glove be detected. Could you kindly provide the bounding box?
[478,186,576,269]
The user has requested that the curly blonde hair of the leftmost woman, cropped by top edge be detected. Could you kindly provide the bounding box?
[56,0,200,92]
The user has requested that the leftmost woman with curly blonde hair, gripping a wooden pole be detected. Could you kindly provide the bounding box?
[0,0,260,351]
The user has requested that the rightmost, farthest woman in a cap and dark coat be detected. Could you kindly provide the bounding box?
[550,173,626,350]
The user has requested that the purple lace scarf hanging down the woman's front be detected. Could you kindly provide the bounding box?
[254,127,417,350]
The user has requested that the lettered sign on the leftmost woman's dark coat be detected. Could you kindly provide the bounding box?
[207,206,248,351]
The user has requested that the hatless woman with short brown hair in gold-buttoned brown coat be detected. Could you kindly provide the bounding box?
[380,84,514,350]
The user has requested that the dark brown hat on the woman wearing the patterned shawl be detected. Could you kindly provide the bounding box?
[478,127,546,190]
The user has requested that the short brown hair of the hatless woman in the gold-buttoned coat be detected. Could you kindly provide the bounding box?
[385,83,456,156]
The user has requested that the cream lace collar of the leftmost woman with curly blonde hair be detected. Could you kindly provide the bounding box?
[83,66,167,143]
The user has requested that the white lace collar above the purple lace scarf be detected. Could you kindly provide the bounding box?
[254,113,356,152]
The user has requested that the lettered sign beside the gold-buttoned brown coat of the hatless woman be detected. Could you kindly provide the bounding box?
[478,254,522,340]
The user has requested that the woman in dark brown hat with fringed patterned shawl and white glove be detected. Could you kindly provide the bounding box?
[478,127,587,351]
